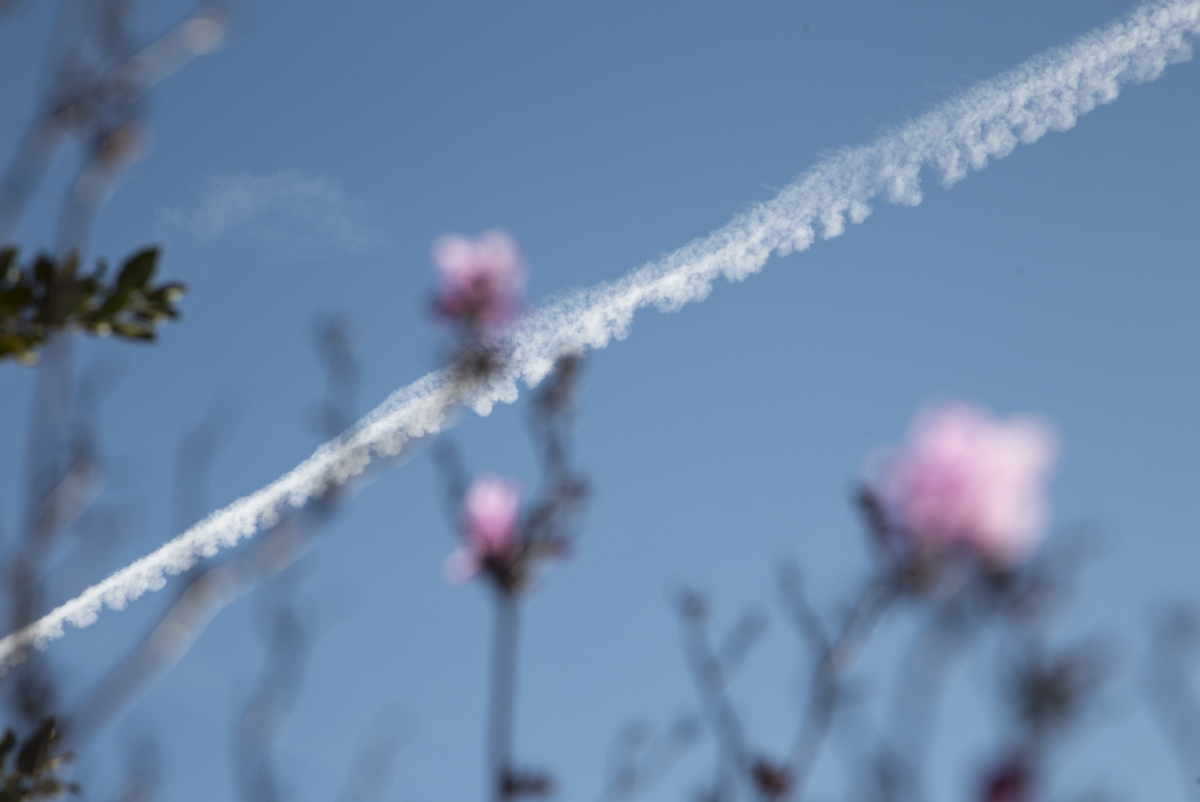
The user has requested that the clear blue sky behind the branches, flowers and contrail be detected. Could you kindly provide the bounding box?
[0,0,1200,800]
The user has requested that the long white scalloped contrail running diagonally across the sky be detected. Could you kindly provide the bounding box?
[0,0,1200,671]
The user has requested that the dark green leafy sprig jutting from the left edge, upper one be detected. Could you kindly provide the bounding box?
[0,247,186,365]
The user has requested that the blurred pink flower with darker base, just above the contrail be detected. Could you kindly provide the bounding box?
[433,231,524,330]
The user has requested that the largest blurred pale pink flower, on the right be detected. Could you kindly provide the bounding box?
[880,403,1057,567]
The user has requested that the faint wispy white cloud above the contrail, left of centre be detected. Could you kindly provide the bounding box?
[157,170,383,252]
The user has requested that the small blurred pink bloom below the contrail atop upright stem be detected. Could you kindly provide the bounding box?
[445,473,521,582]
